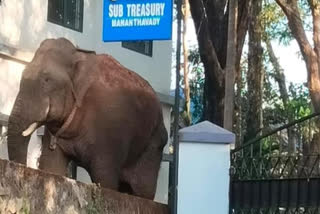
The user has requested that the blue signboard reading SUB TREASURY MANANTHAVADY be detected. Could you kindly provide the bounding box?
[103,0,172,42]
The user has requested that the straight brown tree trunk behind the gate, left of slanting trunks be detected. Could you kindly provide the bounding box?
[244,0,264,141]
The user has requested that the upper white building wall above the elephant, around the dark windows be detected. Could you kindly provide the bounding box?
[0,0,172,94]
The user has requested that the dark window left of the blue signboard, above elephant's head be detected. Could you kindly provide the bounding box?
[48,0,83,32]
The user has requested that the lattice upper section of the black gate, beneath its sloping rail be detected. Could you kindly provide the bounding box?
[231,113,320,180]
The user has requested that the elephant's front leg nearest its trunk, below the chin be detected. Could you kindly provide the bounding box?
[39,129,70,176]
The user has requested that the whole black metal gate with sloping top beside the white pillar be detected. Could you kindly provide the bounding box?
[230,114,320,214]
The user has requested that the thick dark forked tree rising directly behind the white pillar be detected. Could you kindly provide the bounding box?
[189,0,251,125]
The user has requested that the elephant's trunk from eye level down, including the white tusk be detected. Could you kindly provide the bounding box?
[7,79,50,164]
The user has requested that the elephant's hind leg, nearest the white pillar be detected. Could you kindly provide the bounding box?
[121,123,168,200]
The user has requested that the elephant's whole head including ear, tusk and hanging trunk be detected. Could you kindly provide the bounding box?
[8,38,90,164]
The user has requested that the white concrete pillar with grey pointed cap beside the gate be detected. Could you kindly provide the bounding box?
[178,121,235,214]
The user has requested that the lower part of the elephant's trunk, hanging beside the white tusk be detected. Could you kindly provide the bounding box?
[7,96,31,164]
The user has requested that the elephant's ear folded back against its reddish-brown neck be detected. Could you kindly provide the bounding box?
[71,51,97,107]
